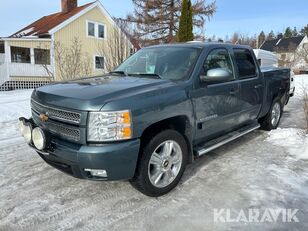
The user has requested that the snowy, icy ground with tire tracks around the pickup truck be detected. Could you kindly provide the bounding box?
[0,76,308,231]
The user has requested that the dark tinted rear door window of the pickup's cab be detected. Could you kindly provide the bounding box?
[234,49,257,79]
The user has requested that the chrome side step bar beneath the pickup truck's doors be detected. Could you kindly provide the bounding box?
[196,124,260,156]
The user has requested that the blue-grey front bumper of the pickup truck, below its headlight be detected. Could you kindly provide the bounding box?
[24,119,140,181]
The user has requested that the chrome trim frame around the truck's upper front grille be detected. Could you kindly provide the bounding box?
[31,99,81,124]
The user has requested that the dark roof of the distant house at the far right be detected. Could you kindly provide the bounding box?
[260,36,305,52]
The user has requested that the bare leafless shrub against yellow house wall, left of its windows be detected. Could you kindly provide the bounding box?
[42,37,92,80]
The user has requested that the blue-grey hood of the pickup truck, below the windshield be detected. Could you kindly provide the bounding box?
[32,76,175,111]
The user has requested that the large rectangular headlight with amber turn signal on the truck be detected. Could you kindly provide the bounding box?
[88,110,132,142]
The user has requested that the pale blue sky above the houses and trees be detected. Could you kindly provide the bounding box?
[0,0,308,38]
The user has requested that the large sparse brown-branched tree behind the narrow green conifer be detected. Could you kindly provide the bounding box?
[126,0,216,45]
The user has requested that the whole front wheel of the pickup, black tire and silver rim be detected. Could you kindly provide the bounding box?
[130,130,188,197]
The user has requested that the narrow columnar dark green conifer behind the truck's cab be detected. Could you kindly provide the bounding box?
[177,0,194,42]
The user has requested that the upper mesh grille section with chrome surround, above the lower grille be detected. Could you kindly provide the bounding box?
[31,100,81,124]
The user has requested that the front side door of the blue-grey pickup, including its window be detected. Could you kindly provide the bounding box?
[193,48,241,141]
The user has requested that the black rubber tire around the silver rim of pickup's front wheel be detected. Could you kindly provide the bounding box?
[130,130,188,197]
